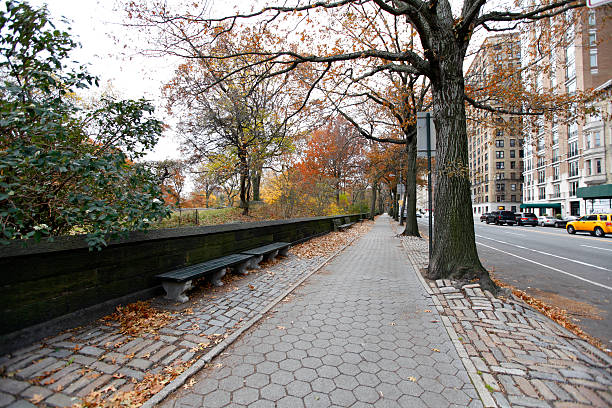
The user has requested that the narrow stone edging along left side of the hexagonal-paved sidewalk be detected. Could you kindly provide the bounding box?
[140,233,359,408]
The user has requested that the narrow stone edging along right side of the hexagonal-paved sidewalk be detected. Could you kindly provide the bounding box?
[400,226,497,408]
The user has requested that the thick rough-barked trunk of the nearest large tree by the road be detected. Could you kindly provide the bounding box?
[427,36,495,289]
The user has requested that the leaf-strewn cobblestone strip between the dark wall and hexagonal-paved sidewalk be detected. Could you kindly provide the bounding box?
[0,254,330,407]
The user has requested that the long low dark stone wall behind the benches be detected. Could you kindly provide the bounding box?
[0,214,367,348]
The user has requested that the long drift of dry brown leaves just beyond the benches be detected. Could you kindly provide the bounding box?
[291,220,374,259]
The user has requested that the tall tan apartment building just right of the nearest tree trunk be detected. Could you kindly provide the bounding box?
[466,34,523,216]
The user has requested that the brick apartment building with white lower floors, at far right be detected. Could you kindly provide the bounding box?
[521,7,612,216]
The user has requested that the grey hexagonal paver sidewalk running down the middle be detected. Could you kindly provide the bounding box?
[162,217,482,408]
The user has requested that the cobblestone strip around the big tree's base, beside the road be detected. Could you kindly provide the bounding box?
[404,233,612,408]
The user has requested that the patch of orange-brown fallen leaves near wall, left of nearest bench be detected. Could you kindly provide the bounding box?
[102,301,173,336]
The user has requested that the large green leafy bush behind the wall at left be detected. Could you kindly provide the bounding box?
[0,1,169,249]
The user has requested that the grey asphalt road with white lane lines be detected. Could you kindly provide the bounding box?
[419,219,612,348]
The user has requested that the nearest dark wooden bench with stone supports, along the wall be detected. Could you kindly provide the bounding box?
[156,254,253,303]
